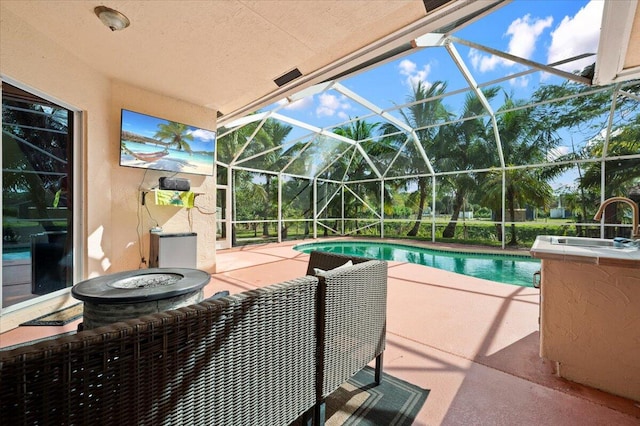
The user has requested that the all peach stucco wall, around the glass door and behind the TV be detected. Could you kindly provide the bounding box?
[0,4,216,332]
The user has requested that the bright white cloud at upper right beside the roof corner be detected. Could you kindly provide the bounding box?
[547,0,604,72]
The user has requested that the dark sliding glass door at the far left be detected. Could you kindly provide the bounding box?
[2,82,74,308]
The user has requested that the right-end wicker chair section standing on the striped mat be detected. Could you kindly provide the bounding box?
[307,251,387,425]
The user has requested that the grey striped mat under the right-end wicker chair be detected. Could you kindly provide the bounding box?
[291,366,429,426]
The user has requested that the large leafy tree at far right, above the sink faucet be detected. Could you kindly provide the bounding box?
[533,82,640,236]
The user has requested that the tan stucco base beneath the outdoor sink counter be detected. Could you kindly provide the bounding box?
[540,259,640,401]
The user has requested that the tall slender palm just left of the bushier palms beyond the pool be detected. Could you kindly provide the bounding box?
[383,81,451,237]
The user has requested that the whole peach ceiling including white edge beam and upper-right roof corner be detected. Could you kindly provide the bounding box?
[0,0,640,119]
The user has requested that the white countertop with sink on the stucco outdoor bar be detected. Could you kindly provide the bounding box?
[530,235,640,268]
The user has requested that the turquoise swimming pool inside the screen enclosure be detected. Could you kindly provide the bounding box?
[294,241,540,287]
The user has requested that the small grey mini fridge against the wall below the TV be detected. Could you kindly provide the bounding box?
[149,232,198,269]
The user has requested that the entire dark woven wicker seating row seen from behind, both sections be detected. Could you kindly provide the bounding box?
[0,254,387,426]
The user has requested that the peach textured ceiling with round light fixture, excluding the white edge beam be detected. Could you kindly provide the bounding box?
[1,0,426,117]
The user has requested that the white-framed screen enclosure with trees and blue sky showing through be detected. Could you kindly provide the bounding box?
[216,1,640,248]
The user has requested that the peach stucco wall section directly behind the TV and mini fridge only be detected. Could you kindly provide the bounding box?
[108,82,216,270]
